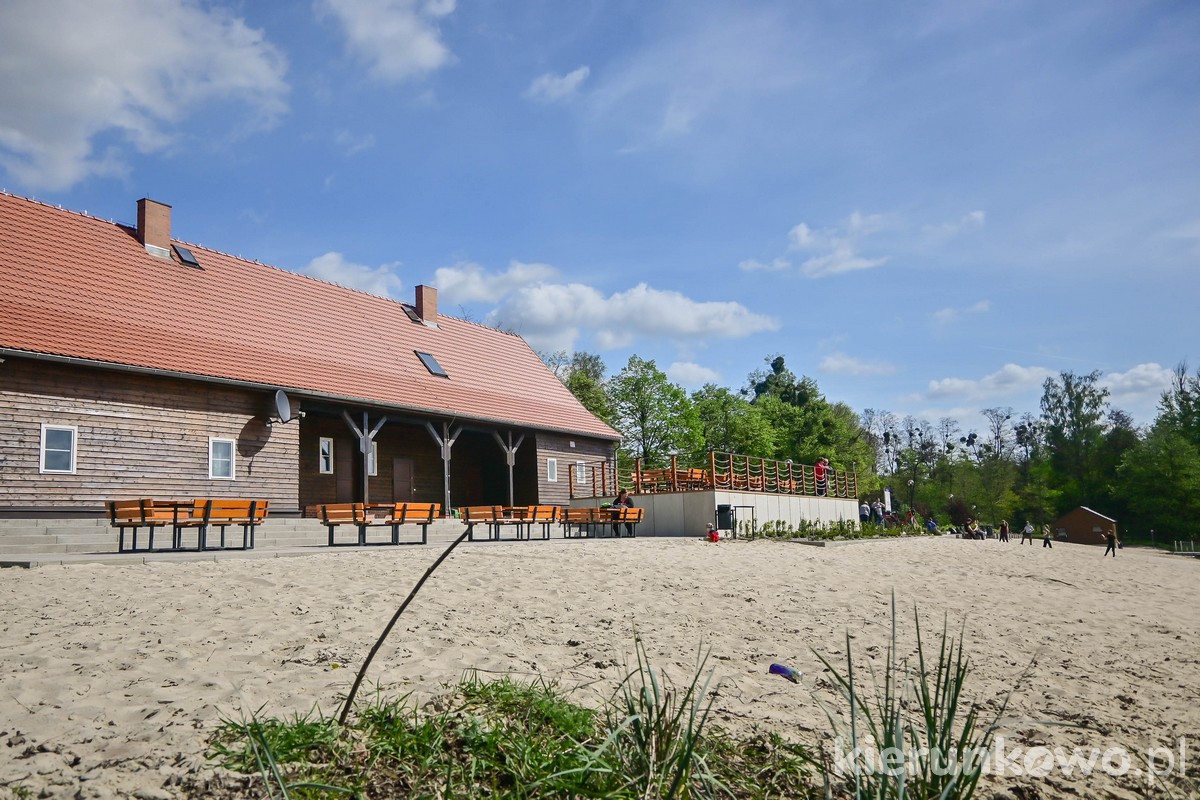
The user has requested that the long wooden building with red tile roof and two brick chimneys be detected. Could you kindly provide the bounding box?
[0,193,619,513]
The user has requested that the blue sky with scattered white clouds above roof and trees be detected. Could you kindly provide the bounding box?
[0,0,1200,428]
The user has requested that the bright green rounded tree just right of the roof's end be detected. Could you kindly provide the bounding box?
[608,355,701,467]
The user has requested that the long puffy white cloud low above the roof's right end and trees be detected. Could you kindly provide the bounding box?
[488,283,779,350]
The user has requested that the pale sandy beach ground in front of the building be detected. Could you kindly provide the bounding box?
[0,537,1200,799]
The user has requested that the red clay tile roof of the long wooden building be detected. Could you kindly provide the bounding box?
[0,193,619,439]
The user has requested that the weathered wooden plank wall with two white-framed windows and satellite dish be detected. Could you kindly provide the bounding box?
[0,357,299,513]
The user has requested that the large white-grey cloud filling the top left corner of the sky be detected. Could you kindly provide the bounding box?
[0,0,287,190]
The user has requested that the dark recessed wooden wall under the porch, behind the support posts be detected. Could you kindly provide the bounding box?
[300,414,448,506]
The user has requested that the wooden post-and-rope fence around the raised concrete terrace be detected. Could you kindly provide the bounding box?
[568,452,858,498]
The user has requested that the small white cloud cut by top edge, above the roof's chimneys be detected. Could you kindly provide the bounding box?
[317,0,455,82]
